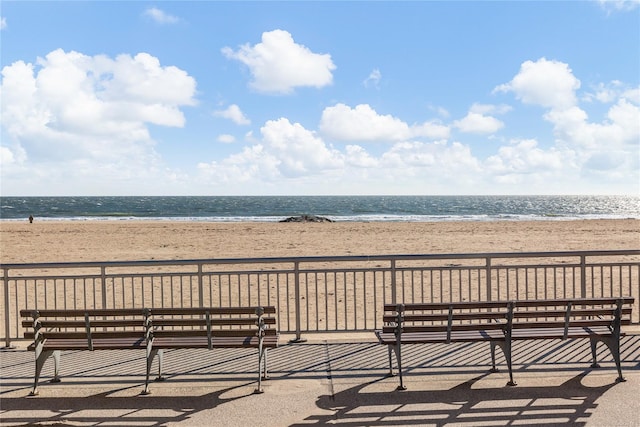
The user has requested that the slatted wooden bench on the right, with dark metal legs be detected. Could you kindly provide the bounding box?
[376,298,634,390]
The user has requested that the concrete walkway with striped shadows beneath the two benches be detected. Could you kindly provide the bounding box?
[0,334,640,427]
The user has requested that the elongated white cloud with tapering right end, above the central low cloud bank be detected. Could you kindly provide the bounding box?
[319,104,449,142]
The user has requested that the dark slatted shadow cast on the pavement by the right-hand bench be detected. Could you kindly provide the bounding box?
[292,372,616,427]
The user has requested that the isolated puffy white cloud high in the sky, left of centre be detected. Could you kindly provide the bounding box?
[222,30,336,94]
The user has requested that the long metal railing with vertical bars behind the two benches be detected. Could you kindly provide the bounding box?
[0,250,640,347]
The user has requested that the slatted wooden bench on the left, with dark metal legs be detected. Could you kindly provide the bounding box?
[20,306,278,395]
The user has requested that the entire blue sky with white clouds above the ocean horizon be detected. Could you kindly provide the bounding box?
[0,0,640,196]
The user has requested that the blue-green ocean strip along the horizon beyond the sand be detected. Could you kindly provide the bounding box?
[0,196,640,222]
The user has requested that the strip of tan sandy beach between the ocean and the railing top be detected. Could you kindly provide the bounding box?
[0,219,640,263]
